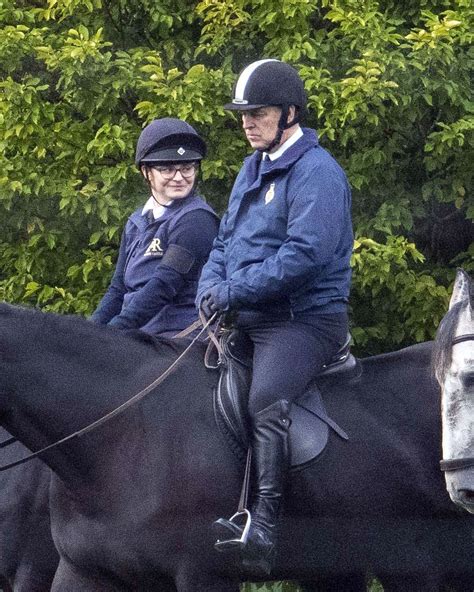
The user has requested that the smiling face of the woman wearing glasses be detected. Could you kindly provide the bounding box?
[142,162,198,205]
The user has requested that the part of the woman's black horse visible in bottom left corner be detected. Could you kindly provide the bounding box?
[0,428,59,592]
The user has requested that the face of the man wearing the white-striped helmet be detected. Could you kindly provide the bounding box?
[242,106,295,152]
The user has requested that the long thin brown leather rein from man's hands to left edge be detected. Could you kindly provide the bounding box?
[0,314,217,472]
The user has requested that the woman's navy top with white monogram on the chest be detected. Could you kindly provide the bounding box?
[91,195,218,335]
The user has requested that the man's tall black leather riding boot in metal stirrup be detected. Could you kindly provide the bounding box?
[216,399,290,574]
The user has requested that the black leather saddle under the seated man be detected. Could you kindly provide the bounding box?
[214,329,358,469]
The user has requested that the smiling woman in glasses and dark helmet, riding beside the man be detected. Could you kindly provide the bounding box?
[91,117,218,335]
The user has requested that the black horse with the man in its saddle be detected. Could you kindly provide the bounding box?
[0,304,474,592]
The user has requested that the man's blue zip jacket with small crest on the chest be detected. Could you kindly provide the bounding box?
[196,129,353,318]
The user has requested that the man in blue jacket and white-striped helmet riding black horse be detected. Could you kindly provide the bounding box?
[196,59,353,574]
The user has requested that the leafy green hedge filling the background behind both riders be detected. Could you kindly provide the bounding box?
[0,0,474,353]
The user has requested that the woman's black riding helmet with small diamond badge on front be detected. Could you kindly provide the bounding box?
[135,117,207,167]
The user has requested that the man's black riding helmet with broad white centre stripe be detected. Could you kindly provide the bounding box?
[224,59,306,151]
